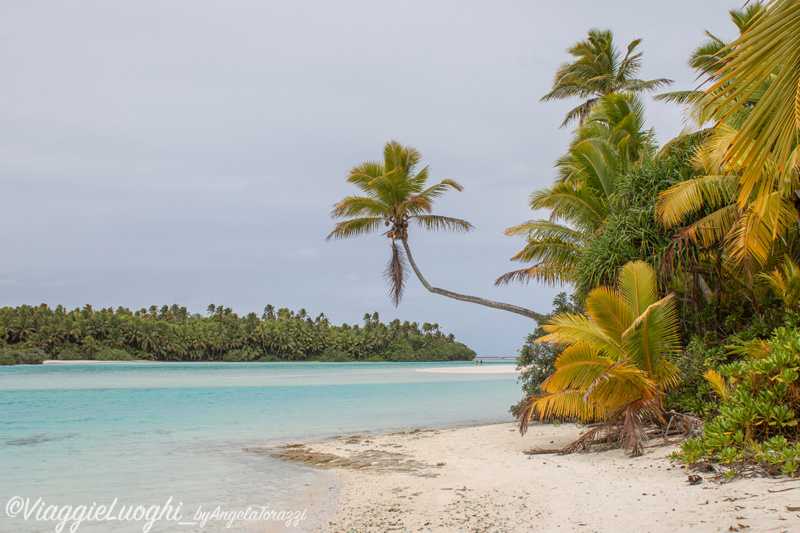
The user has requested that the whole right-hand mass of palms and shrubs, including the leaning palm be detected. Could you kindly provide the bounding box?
[328,0,800,475]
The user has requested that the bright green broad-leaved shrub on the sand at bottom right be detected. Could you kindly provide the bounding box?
[675,327,800,476]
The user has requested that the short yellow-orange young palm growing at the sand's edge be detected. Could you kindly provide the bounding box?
[519,261,680,455]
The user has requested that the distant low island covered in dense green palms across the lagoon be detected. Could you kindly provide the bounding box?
[0,304,476,365]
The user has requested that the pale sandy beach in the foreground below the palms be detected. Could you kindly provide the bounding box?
[272,422,800,533]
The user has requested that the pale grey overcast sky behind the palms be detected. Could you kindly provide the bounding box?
[0,0,743,356]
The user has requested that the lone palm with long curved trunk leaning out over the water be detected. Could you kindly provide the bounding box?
[327,141,541,318]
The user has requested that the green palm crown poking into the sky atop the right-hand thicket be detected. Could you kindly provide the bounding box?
[542,28,672,127]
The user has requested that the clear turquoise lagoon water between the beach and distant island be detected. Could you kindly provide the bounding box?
[0,361,520,532]
